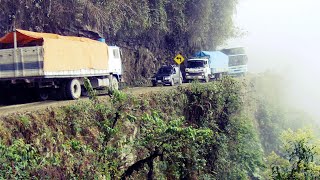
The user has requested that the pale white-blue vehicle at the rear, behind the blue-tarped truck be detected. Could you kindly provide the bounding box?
[221,47,248,76]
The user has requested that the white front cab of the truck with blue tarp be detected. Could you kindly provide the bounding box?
[185,57,211,82]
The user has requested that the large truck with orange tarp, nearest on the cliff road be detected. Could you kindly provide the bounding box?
[0,29,122,100]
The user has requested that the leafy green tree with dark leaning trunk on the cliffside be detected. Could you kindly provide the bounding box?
[121,112,213,179]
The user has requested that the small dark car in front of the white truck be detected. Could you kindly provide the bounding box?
[151,65,182,86]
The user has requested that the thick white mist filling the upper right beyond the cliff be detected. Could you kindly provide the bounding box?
[227,0,320,124]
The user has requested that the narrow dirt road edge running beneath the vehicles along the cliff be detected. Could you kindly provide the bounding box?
[0,86,176,116]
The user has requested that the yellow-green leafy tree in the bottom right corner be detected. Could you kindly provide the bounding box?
[268,129,320,179]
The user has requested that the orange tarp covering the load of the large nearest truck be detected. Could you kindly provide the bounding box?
[0,29,108,75]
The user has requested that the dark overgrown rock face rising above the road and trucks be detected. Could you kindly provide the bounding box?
[0,0,237,85]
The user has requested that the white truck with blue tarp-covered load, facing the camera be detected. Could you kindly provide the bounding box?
[185,51,229,82]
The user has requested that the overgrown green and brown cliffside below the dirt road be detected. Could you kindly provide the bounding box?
[0,78,264,179]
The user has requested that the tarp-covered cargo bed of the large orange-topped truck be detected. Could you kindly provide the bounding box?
[0,30,112,79]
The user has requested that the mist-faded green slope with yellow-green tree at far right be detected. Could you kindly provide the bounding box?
[251,72,320,179]
